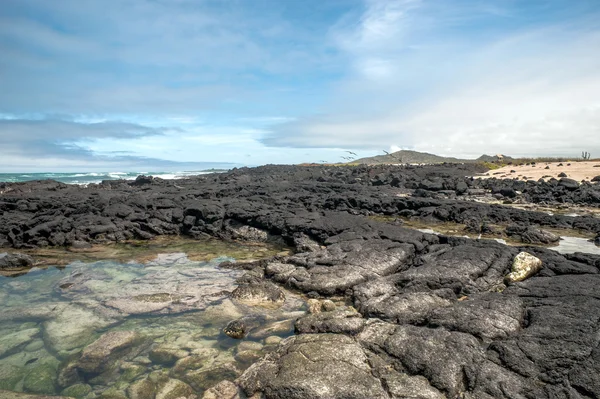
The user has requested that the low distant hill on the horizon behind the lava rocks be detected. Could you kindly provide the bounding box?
[351,150,513,165]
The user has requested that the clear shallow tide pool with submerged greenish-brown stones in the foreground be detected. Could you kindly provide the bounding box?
[0,247,305,399]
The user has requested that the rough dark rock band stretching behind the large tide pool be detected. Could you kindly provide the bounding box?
[0,165,600,248]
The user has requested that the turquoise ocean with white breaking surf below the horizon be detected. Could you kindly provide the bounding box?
[0,169,227,184]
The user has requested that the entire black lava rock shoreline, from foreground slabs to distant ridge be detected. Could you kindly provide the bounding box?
[0,165,600,399]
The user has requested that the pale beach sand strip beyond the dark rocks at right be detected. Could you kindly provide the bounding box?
[478,161,600,182]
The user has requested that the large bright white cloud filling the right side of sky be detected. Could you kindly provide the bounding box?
[264,1,600,157]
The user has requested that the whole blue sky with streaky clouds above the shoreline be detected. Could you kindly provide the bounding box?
[0,0,600,172]
